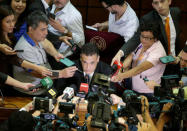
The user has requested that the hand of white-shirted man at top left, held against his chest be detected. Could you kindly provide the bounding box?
[49,18,66,33]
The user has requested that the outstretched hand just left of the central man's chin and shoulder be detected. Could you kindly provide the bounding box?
[59,66,78,78]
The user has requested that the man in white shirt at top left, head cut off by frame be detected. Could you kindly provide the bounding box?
[47,0,85,57]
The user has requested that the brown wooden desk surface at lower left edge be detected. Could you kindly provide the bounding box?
[0,97,32,122]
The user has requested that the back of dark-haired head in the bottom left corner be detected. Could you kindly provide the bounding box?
[8,111,35,131]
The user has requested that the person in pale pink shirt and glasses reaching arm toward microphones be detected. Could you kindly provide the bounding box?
[111,23,166,97]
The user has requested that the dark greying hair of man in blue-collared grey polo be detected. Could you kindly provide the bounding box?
[27,11,49,29]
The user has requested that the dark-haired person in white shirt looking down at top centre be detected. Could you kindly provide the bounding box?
[93,0,139,42]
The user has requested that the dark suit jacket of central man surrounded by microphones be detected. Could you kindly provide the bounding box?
[56,60,116,94]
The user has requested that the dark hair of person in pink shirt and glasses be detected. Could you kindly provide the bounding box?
[140,22,160,40]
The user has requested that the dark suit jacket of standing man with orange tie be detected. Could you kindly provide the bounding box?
[121,7,181,57]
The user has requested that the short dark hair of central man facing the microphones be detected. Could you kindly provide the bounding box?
[81,43,99,56]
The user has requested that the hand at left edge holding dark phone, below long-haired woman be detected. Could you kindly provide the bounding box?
[0,44,16,55]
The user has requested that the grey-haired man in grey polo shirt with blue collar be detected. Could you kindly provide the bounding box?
[14,11,77,95]
